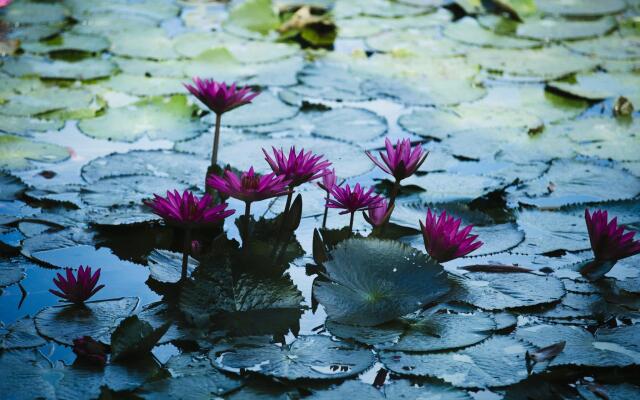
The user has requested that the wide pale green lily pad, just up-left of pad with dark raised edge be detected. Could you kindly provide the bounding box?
[468,46,598,81]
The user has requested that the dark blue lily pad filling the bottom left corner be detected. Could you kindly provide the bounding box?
[0,349,56,400]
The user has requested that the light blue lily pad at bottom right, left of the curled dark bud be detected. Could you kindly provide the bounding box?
[380,336,541,388]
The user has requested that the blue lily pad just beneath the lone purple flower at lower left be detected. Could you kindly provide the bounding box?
[35,297,138,346]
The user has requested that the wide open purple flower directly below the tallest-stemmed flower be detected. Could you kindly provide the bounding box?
[207,167,289,203]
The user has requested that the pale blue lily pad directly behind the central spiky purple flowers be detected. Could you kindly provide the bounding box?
[218,138,373,178]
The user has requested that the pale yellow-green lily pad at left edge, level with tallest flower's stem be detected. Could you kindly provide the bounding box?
[0,135,69,170]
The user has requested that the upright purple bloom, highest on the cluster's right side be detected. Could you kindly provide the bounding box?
[366,139,429,182]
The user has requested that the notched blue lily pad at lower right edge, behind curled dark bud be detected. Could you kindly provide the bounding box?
[516,325,640,367]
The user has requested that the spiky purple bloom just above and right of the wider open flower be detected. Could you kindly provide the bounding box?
[262,146,331,187]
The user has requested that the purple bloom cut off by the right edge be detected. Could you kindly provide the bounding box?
[584,209,640,261]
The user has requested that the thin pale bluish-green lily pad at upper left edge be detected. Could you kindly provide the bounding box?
[2,55,116,80]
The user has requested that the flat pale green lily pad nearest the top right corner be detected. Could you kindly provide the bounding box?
[516,17,617,41]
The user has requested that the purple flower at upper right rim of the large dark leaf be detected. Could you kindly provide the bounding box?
[420,210,482,262]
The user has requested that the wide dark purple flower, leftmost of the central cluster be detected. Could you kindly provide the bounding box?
[145,190,235,229]
